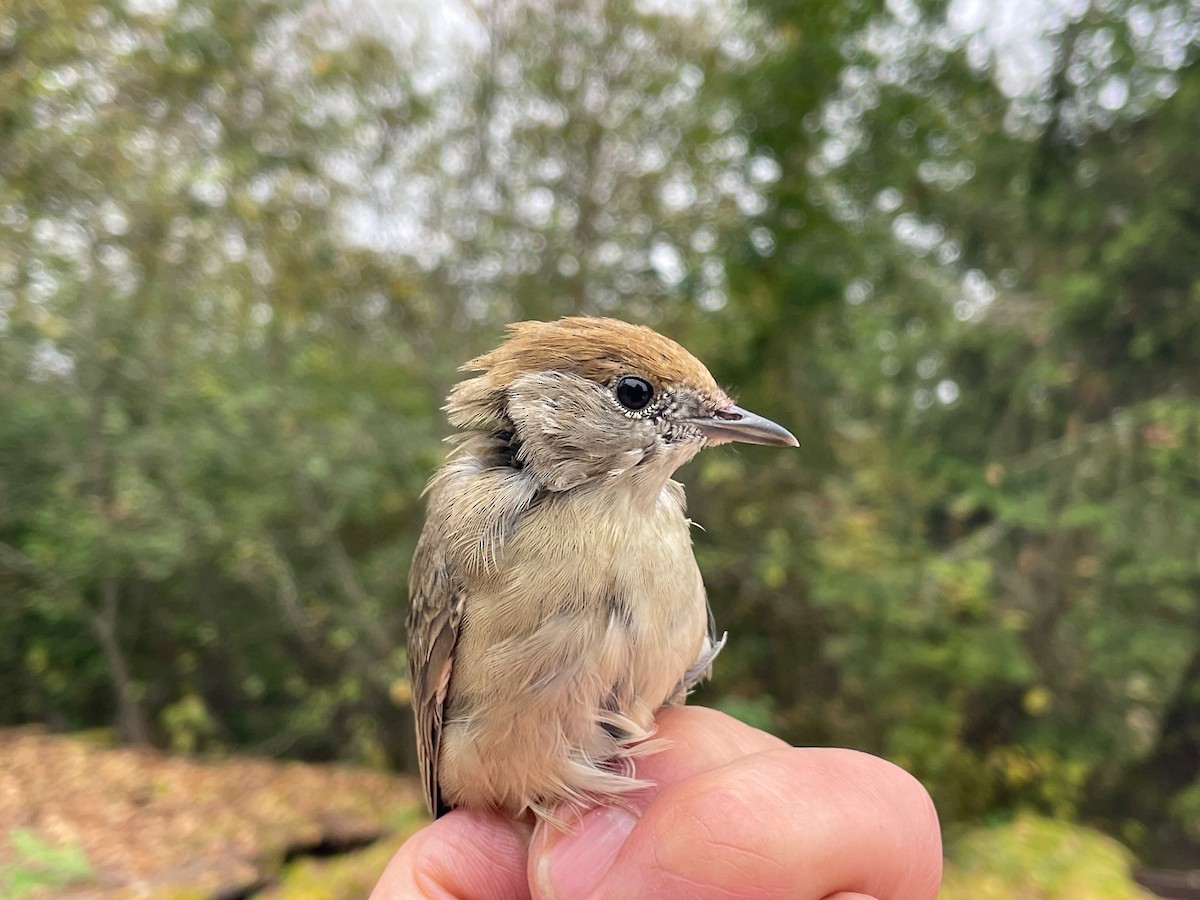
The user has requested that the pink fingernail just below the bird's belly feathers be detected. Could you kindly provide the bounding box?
[538,806,637,900]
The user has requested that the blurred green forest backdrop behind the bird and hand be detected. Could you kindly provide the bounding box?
[0,0,1200,888]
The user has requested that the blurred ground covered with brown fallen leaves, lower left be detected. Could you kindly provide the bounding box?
[0,728,419,899]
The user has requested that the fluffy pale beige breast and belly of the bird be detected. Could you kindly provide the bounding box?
[438,481,708,812]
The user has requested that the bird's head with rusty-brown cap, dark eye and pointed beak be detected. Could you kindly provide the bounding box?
[446,317,798,491]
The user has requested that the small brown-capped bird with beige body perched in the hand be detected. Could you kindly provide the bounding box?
[408,317,798,827]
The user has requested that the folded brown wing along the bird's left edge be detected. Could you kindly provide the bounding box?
[408,534,464,817]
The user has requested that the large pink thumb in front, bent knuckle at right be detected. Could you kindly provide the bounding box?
[530,749,942,900]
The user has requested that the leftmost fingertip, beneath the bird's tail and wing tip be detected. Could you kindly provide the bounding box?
[371,810,529,900]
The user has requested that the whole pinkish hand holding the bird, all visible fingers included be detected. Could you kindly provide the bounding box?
[371,707,942,900]
